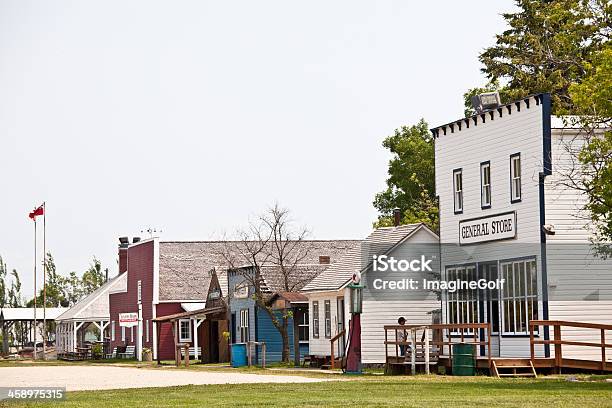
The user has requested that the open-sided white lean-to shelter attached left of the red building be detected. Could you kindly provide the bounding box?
[55,273,127,355]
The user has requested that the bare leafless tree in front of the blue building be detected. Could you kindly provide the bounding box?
[224,204,312,363]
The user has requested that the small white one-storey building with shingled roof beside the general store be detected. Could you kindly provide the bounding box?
[302,224,440,364]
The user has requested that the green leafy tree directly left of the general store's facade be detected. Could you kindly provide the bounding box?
[373,119,438,231]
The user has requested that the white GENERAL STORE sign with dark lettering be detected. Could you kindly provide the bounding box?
[459,211,516,245]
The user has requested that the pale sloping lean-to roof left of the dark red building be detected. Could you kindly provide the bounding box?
[56,273,127,321]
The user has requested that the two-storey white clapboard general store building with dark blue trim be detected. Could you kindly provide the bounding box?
[432,94,612,359]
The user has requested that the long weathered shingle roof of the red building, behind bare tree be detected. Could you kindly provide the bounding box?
[159,240,360,302]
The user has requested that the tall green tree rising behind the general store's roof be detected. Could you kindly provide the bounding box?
[465,0,612,114]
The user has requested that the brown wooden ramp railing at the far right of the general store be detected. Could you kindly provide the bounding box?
[529,320,612,371]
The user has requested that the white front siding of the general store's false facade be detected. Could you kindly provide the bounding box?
[435,98,543,357]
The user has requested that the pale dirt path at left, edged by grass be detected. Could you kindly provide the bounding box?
[0,366,326,391]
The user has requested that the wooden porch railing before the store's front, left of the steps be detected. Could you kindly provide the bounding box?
[384,323,491,368]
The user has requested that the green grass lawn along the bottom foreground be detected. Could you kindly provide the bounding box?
[5,376,612,408]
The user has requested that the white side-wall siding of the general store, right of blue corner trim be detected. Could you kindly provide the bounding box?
[545,129,612,361]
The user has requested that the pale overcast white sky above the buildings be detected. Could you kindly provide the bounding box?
[0,0,514,298]
